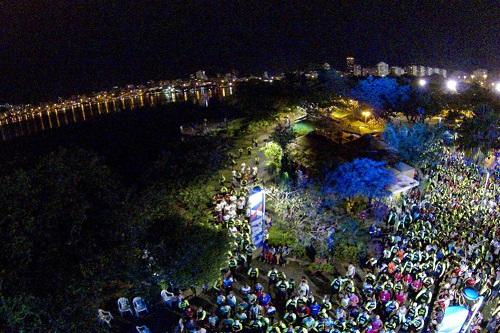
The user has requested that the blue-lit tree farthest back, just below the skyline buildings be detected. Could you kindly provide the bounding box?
[351,76,410,118]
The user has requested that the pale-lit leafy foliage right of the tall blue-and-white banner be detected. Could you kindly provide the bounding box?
[267,181,366,262]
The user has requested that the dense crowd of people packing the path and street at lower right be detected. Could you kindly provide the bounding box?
[171,149,500,333]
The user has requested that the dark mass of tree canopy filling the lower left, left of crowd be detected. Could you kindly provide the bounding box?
[0,146,233,332]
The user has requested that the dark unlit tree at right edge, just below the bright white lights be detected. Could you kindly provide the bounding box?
[458,104,500,154]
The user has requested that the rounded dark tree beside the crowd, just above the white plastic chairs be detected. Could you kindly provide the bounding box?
[139,208,230,288]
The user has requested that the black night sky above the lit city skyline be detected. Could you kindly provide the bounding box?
[0,0,500,103]
